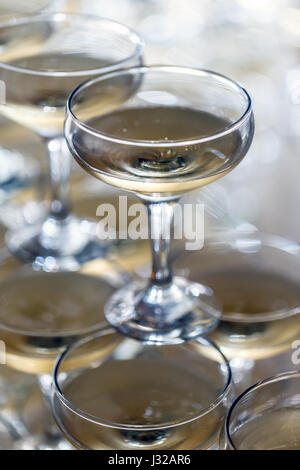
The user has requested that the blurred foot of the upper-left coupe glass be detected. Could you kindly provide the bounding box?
[6,216,109,271]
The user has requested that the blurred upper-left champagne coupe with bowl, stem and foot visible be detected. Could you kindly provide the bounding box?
[0,13,142,270]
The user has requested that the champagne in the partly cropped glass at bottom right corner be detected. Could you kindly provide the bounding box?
[232,407,300,450]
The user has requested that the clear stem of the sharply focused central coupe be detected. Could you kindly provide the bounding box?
[146,201,176,286]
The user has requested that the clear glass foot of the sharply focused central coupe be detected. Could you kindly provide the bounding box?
[105,277,221,344]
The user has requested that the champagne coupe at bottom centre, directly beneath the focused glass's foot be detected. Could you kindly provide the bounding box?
[52,329,232,450]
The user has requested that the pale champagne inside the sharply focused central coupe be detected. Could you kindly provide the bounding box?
[72,104,245,195]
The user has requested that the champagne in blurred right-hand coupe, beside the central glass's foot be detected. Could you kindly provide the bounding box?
[204,269,300,360]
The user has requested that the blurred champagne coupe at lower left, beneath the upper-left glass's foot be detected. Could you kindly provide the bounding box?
[0,256,124,449]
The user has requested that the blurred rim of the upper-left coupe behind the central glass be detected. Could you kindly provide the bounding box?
[0,12,144,78]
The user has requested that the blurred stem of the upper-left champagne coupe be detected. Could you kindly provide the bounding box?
[46,137,71,221]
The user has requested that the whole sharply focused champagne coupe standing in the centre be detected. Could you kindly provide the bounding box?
[65,66,254,342]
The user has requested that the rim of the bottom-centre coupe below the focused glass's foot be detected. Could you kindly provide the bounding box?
[52,327,232,430]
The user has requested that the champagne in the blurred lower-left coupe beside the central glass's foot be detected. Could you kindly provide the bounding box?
[0,272,114,374]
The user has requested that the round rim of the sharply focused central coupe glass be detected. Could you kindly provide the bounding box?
[66,65,252,148]
